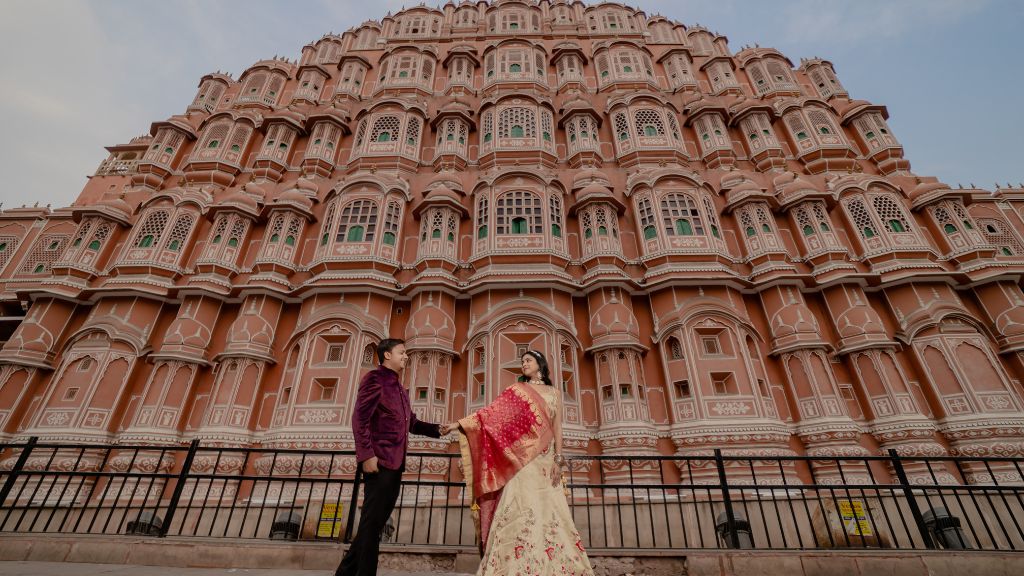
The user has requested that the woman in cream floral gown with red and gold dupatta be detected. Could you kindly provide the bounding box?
[451,351,594,576]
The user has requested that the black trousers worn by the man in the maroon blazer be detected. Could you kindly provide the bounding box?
[335,466,401,576]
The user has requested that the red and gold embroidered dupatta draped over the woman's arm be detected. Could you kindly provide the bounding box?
[459,382,554,550]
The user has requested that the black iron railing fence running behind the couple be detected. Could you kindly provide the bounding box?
[0,439,1024,550]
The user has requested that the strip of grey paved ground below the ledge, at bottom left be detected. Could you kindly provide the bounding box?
[0,562,465,576]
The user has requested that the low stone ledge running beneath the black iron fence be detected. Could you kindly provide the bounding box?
[0,534,1024,576]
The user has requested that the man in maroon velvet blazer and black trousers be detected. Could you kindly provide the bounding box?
[335,338,450,576]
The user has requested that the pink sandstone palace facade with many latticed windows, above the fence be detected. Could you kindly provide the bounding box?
[0,0,1024,482]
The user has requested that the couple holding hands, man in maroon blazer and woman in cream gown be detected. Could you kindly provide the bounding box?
[335,338,594,576]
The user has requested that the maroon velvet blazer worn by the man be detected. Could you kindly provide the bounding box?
[352,366,441,470]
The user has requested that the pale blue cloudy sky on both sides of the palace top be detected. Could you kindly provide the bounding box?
[0,0,1024,208]
